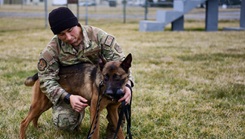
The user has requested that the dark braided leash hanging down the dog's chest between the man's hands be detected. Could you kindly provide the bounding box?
[87,81,103,139]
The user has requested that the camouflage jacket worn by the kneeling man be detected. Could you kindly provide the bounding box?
[37,26,132,105]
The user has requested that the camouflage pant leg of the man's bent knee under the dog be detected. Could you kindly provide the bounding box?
[53,102,85,131]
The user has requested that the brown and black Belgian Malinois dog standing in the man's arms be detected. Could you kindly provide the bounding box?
[20,54,132,139]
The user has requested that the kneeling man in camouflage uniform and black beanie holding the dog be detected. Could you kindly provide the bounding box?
[37,7,133,135]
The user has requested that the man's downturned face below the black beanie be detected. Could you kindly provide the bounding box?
[57,26,82,46]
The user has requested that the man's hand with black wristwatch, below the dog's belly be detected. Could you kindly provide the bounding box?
[70,95,88,112]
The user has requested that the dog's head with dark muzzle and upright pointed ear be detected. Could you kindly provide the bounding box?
[100,54,132,100]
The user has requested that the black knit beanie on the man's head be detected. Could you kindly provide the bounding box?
[48,7,78,34]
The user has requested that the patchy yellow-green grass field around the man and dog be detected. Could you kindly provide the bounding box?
[0,4,245,139]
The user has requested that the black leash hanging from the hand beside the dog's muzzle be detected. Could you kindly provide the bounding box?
[113,87,133,139]
